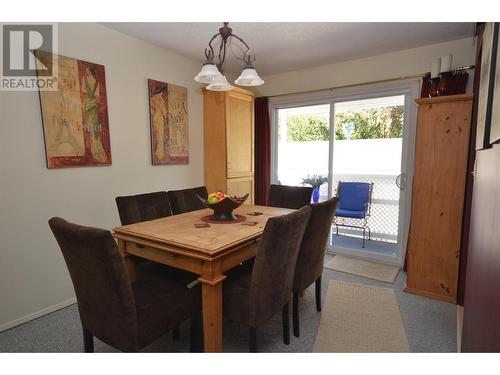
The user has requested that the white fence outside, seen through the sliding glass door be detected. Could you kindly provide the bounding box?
[276,138,402,242]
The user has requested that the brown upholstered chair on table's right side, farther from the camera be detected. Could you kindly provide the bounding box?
[293,198,339,337]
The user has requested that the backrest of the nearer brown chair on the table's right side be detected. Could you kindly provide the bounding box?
[249,206,311,327]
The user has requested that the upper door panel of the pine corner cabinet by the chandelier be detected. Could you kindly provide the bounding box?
[226,92,253,178]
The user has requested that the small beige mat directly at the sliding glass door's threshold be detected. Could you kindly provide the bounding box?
[325,255,399,284]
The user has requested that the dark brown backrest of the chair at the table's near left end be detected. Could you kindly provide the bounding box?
[49,217,137,351]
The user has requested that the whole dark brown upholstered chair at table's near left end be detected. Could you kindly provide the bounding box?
[49,217,201,352]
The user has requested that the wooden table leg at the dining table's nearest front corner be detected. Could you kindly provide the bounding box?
[199,275,226,353]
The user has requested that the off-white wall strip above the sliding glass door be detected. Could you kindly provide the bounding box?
[256,38,476,96]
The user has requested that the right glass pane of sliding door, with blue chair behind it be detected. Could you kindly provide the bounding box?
[331,95,405,258]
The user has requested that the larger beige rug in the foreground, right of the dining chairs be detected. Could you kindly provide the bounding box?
[314,280,410,353]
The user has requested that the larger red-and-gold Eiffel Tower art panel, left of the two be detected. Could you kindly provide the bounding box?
[36,50,111,169]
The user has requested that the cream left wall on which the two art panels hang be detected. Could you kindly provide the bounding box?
[0,23,203,330]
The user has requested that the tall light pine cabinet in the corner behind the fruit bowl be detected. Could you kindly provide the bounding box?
[203,88,254,204]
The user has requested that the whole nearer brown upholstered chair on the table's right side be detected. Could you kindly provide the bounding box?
[222,207,311,352]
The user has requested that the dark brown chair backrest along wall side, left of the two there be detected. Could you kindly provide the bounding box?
[115,191,172,225]
